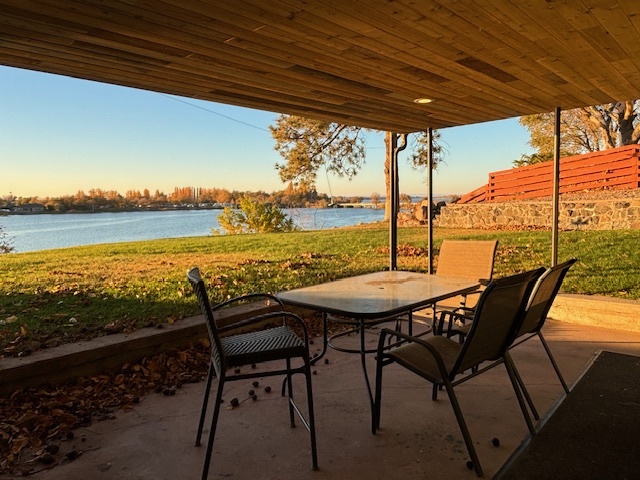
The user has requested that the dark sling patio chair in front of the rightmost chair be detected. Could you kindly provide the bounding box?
[372,268,544,477]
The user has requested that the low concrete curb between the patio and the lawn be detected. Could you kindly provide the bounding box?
[0,294,640,395]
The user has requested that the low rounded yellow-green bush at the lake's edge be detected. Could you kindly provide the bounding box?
[214,195,296,235]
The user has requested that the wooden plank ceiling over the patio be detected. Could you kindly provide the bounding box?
[0,0,640,133]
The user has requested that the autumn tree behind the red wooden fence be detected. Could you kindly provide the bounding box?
[513,100,640,167]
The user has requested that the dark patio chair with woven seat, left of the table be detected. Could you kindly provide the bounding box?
[187,268,318,480]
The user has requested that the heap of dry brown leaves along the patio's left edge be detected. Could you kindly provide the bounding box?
[0,341,210,474]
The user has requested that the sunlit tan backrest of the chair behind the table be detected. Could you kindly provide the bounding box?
[436,240,498,281]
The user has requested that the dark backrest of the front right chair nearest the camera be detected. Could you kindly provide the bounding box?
[450,268,545,378]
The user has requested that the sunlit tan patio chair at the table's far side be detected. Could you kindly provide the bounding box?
[433,240,498,334]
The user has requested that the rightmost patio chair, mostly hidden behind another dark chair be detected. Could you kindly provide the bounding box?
[447,258,577,420]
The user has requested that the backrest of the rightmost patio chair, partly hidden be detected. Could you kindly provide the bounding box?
[516,258,577,338]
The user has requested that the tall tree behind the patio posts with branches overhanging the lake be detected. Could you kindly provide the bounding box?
[269,115,444,218]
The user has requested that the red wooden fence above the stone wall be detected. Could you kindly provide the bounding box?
[458,145,640,203]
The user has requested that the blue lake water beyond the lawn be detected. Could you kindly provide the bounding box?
[0,208,384,252]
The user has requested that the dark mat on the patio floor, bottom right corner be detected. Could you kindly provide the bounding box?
[494,351,640,480]
